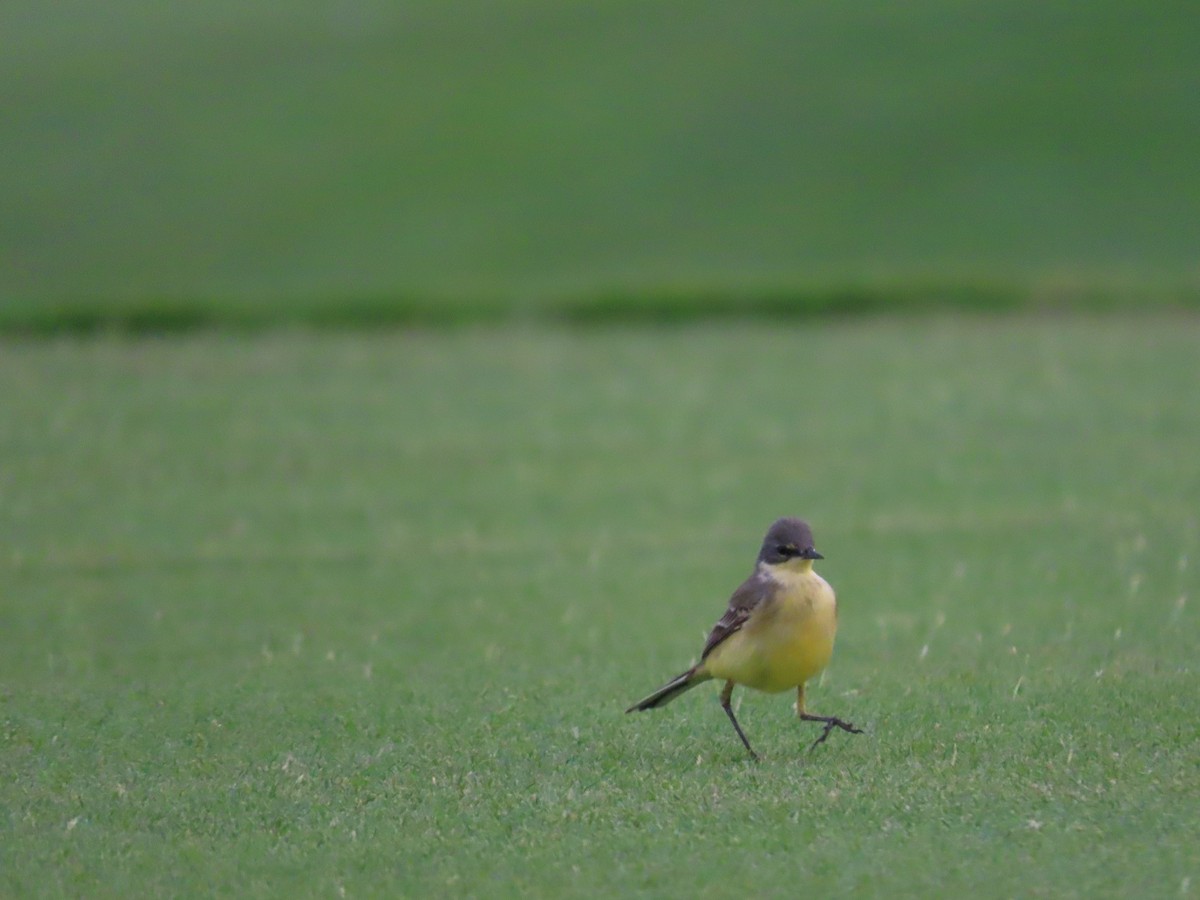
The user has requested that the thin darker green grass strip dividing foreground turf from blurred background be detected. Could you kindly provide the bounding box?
[0,282,1200,337]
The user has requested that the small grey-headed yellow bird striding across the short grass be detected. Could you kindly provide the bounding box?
[625,516,863,760]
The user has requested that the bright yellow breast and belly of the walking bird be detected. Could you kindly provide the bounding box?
[704,575,838,694]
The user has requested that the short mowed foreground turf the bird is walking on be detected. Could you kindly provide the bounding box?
[0,316,1200,896]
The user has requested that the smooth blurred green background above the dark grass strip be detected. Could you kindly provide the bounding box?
[0,0,1200,317]
